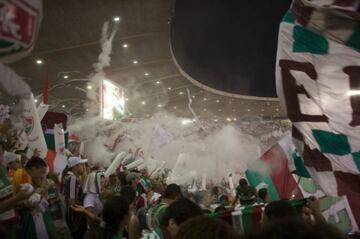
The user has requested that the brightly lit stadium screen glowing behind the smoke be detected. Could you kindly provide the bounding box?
[100,80,125,120]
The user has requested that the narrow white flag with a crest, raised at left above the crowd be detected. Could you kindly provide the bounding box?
[21,94,47,158]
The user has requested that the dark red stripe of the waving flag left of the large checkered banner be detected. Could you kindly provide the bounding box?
[261,144,303,199]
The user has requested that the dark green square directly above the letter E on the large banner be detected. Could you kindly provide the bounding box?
[293,26,329,55]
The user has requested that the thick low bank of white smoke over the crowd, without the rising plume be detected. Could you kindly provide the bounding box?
[69,112,259,183]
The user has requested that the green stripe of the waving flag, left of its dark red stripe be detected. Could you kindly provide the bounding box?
[245,170,280,201]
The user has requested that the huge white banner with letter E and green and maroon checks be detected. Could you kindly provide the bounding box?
[276,3,360,230]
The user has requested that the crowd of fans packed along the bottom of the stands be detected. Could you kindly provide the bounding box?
[0,140,356,239]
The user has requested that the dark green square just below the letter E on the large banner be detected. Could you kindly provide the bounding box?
[312,129,351,155]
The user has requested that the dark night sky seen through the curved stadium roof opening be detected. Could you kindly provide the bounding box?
[171,0,291,97]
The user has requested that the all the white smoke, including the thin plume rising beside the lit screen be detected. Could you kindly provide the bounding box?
[69,20,286,184]
